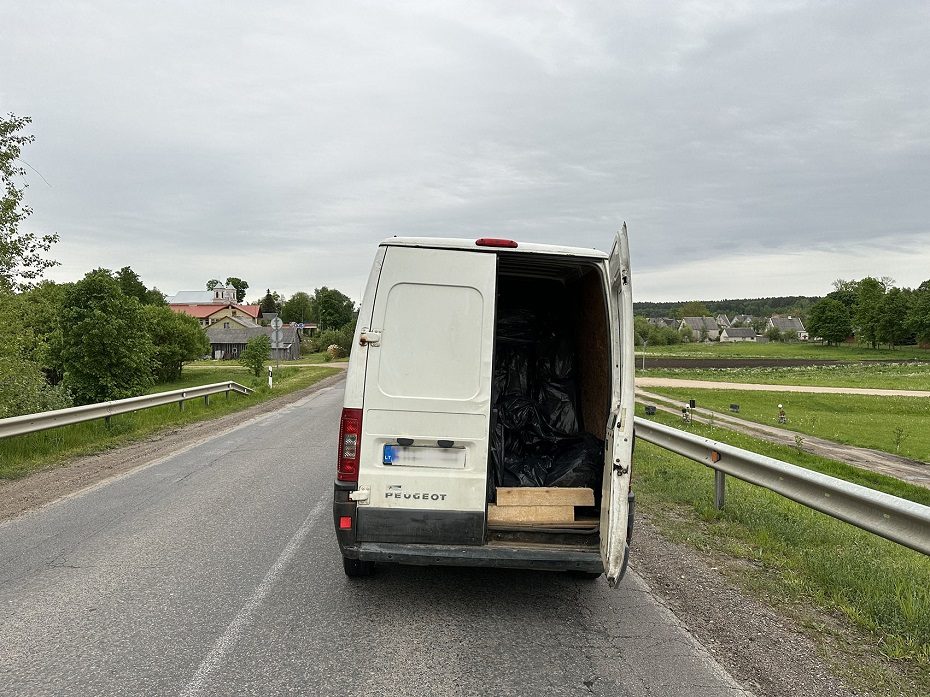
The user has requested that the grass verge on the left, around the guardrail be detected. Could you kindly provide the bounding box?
[0,366,340,479]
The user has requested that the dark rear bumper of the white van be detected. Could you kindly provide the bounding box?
[340,542,604,573]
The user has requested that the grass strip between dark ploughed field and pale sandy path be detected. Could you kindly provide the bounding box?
[636,362,930,390]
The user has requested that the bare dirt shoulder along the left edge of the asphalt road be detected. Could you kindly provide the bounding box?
[0,372,345,520]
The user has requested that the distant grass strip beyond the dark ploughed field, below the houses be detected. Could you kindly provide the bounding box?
[636,341,930,365]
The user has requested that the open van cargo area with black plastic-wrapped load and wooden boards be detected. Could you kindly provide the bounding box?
[488,254,611,544]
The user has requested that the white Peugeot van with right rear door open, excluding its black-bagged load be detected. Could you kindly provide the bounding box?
[333,225,634,585]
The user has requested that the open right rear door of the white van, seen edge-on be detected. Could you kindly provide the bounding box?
[601,223,634,586]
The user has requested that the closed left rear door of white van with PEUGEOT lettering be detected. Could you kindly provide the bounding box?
[357,245,497,544]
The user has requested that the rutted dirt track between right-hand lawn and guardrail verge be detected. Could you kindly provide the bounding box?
[636,383,930,488]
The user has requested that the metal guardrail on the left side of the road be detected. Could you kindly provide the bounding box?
[0,382,253,438]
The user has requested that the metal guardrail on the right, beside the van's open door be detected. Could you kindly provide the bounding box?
[634,417,930,555]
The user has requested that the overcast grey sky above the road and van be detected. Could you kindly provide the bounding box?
[0,0,930,300]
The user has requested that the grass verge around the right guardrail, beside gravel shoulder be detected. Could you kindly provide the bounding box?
[634,406,930,694]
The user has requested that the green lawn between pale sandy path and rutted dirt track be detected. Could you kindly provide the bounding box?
[649,387,930,467]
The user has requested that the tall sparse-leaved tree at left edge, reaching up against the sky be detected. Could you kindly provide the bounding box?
[0,114,58,291]
